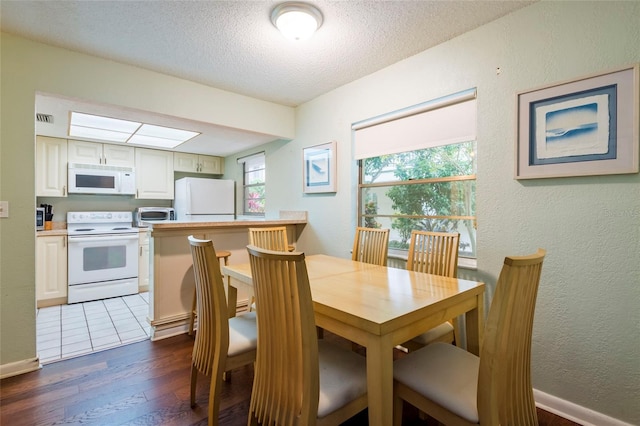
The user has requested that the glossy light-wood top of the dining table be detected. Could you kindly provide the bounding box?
[223,255,484,334]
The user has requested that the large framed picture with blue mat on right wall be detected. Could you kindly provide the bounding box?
[515,64,640,179]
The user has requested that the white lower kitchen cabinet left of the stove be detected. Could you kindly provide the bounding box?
[36,235,67,308]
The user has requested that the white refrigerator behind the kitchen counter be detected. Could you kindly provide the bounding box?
[173,177,235,222]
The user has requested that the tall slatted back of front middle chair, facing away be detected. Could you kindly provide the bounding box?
[247,245,320,425]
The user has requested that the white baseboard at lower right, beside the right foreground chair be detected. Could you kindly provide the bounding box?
[533,389,633,426]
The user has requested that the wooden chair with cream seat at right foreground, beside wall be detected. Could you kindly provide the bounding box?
[393,249,545,426]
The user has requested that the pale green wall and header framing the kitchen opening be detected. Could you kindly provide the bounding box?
[0,33,295,373]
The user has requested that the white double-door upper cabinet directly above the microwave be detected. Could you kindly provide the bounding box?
[69,139,135,167]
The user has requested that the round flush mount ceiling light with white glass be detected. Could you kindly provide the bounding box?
[271,2,322,40]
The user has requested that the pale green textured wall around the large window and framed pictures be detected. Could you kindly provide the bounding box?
[267,2,640,424]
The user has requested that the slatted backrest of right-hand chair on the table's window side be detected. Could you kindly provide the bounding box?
[407,230,460,278]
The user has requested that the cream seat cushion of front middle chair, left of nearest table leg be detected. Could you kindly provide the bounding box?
[318,340,367,419]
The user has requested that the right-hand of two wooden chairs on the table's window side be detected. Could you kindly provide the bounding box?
[401,230,460,351]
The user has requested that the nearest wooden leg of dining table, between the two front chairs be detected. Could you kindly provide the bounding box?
[366,335,393,426]
